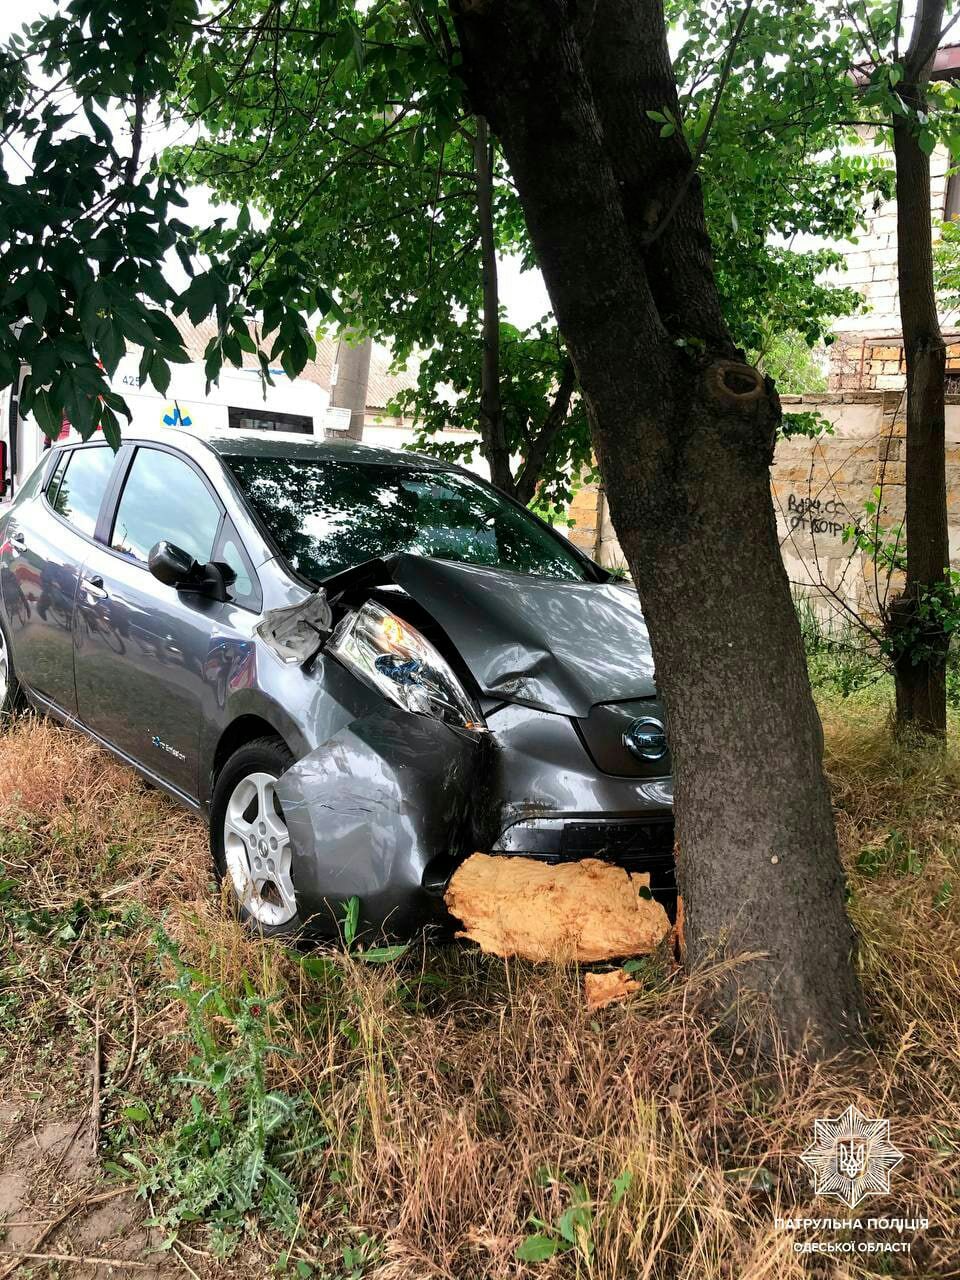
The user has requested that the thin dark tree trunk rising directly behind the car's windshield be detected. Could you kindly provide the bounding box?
[474,116,513,494]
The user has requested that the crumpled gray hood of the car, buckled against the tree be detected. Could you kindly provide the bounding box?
[389,553,655,717]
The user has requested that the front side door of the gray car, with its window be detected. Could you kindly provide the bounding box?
[76,444,252,799]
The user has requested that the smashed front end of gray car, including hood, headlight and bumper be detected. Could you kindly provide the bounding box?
[261,553,676,937]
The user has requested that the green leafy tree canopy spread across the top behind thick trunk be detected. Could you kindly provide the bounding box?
[0,0,888,503]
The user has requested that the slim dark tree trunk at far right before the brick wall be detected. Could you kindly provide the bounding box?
[891,0,950,737]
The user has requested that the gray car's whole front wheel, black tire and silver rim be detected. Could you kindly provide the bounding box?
[210,737,303,938]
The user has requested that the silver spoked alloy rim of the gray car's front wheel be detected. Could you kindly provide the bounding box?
[224,772,297,925]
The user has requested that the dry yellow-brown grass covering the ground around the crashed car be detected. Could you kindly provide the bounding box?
[0,707,960,1280]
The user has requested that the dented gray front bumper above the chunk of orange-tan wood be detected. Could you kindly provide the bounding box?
[276,704,676,936]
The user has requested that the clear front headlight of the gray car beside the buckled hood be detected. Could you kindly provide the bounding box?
[326,600,486,732]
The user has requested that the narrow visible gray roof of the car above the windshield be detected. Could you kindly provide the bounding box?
[99,426,457,471]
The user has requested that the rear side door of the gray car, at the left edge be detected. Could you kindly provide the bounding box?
[0,443,116,716]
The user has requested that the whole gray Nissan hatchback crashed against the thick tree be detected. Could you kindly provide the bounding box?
[0,429,676,936]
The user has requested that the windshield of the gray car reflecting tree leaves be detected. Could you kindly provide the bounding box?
[224,456,589,582]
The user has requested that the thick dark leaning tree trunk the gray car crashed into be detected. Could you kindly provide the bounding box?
[454,0,863,1051]
